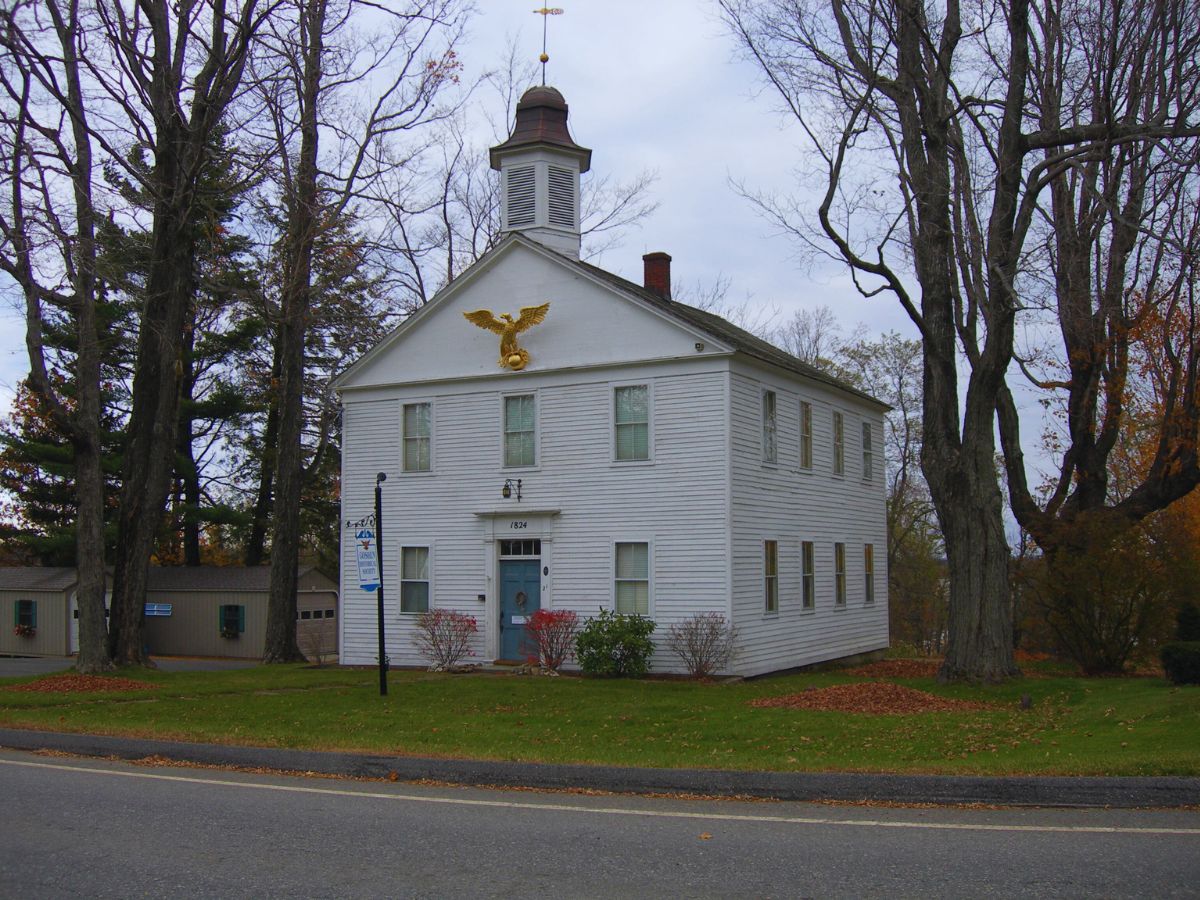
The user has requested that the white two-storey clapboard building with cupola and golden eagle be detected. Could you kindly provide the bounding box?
[336,86,888,674]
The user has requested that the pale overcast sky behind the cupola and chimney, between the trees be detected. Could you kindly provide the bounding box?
[0,0,926,427]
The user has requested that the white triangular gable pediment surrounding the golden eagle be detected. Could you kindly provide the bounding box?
[336,236,726,390]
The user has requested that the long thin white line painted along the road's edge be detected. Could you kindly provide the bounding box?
[0,760,1200,836]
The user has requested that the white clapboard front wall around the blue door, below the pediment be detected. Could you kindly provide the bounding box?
[342,360,730,671]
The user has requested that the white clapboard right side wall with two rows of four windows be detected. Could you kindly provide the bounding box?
[731,364,888,674]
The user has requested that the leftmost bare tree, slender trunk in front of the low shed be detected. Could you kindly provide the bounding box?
[0,0,112,672]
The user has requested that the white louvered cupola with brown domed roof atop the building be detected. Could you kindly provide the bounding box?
[491,85,592,259]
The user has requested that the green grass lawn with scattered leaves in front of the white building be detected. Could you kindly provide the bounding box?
[0,666,1200,775]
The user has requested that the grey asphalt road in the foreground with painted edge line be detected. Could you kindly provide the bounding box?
[7,751,1200,898]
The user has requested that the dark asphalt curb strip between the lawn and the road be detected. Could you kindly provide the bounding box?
[0,728,1200,809]
